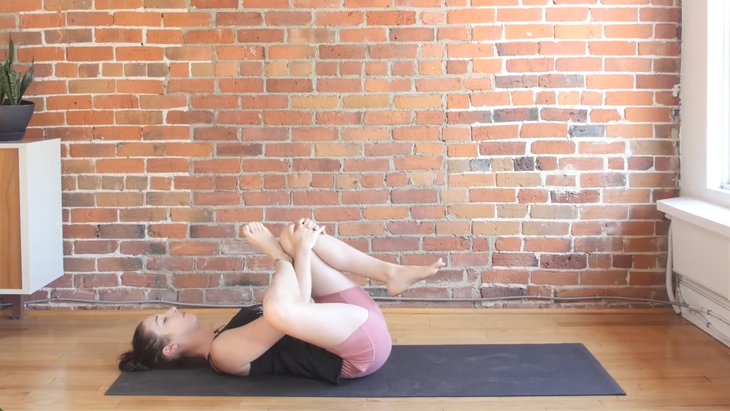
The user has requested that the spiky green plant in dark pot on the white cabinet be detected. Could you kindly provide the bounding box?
[0,38,35,141]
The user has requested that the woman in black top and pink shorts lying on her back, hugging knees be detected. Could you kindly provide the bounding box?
[119,219,444,384]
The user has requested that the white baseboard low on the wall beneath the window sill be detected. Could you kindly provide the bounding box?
[679,276,730,347]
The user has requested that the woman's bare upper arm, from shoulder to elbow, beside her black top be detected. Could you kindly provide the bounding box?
[210,317,285,376]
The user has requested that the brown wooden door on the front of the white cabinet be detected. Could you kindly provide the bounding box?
[0,149,23,290]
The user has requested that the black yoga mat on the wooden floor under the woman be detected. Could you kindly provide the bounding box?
[106,344,625,398]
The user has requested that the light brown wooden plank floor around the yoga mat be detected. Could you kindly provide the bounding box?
[0,309,730,411]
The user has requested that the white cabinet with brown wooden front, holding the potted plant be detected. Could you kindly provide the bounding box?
[0,138,63,318]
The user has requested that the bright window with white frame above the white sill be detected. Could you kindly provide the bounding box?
[679,0,730,209]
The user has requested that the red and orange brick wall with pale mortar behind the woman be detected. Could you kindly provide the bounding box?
[0,0,681,306]
